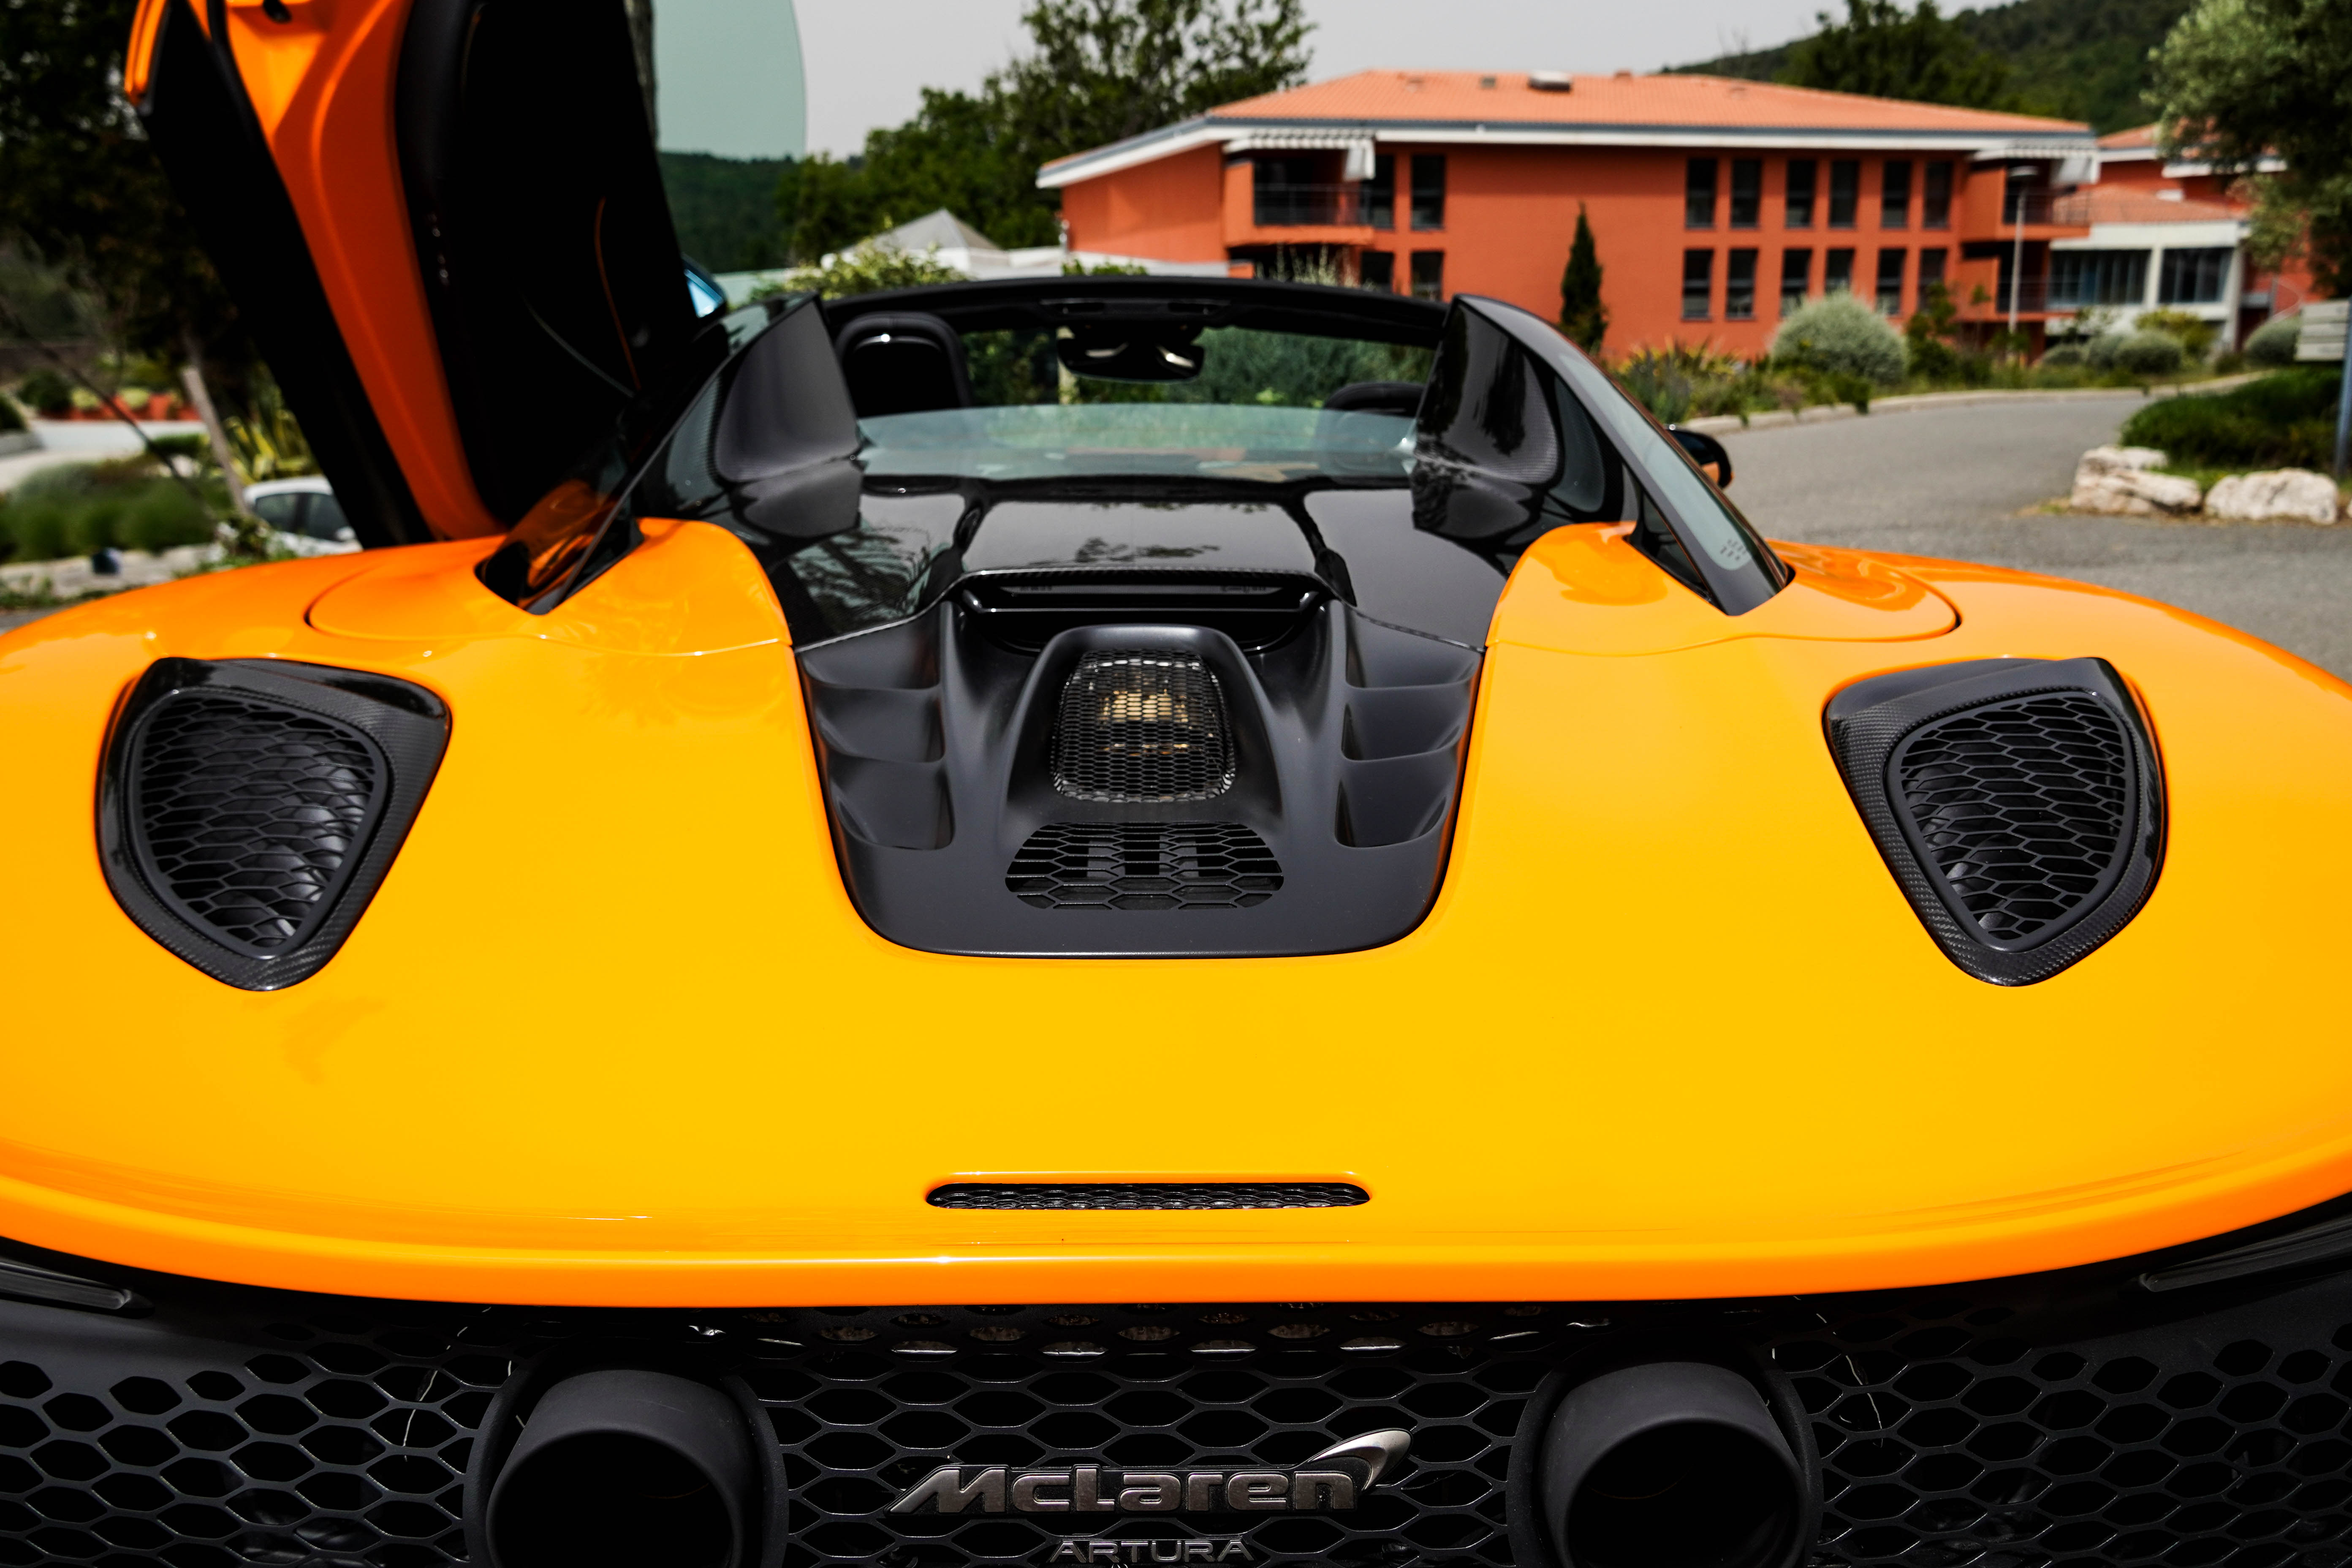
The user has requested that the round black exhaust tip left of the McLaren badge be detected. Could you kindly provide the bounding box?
[487,1370,760,1568]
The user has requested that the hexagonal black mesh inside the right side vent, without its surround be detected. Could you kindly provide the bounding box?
[1891,691,2131,943]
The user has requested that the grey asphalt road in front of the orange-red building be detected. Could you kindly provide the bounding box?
[1724,393,2352,679]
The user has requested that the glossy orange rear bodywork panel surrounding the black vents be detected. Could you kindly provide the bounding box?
[0,524,2352,1305]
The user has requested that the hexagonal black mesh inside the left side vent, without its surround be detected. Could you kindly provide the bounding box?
[129,691,386,954]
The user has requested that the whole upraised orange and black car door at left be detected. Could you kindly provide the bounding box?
[125,0,694,543]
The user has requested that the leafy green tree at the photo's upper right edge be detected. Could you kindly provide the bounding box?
[2150,0,2352,294]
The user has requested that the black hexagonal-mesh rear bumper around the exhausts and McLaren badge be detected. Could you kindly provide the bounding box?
[0,1269,2352,1568]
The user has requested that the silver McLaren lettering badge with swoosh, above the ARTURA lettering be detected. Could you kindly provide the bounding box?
[889,1432,1414,1514]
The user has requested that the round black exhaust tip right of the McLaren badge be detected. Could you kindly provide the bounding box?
[1540,1361,1806,1568]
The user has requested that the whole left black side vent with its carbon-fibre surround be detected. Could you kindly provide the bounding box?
[99,658,447,990]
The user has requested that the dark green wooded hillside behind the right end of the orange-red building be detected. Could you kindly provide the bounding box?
[1675,0,2192,132]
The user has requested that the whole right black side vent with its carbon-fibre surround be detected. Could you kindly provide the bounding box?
[1828,658,2164,985]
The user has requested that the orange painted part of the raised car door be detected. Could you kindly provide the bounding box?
[127,0,503,538]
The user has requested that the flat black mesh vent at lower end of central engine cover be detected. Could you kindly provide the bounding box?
[1004,823,1282,910]
